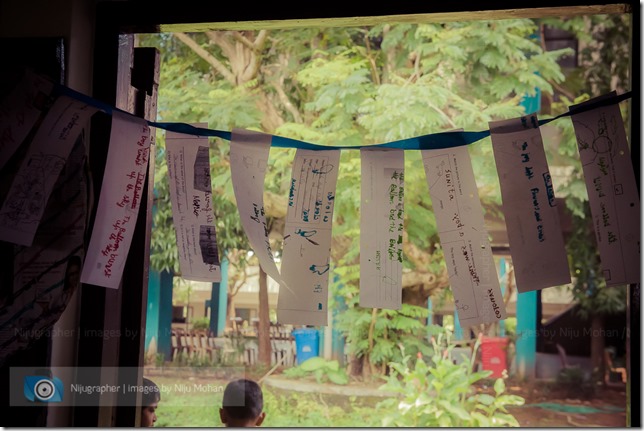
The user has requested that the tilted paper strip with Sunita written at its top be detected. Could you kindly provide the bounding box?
[421,146,506,327]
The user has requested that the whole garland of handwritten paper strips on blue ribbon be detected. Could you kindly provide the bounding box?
[0,73,641,326]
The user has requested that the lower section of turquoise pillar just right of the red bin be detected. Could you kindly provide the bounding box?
[516,291,537,379]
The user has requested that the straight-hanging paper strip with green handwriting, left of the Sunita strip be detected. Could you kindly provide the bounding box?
[360,148,405,310]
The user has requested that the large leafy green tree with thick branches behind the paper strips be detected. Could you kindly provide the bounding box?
[144,19,566,369]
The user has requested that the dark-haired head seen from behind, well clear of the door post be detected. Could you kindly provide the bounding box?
[219,379,266,427]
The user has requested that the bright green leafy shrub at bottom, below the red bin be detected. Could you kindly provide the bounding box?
[376,332,525,428]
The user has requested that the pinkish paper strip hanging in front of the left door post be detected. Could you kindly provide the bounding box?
[81,111,150,289]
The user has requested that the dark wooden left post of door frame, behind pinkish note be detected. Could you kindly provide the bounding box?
[74,31,159,426]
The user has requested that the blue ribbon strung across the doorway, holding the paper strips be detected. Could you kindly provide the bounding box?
[55,85,631,150]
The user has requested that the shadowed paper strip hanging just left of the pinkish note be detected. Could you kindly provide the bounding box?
[0,96,96,246]
